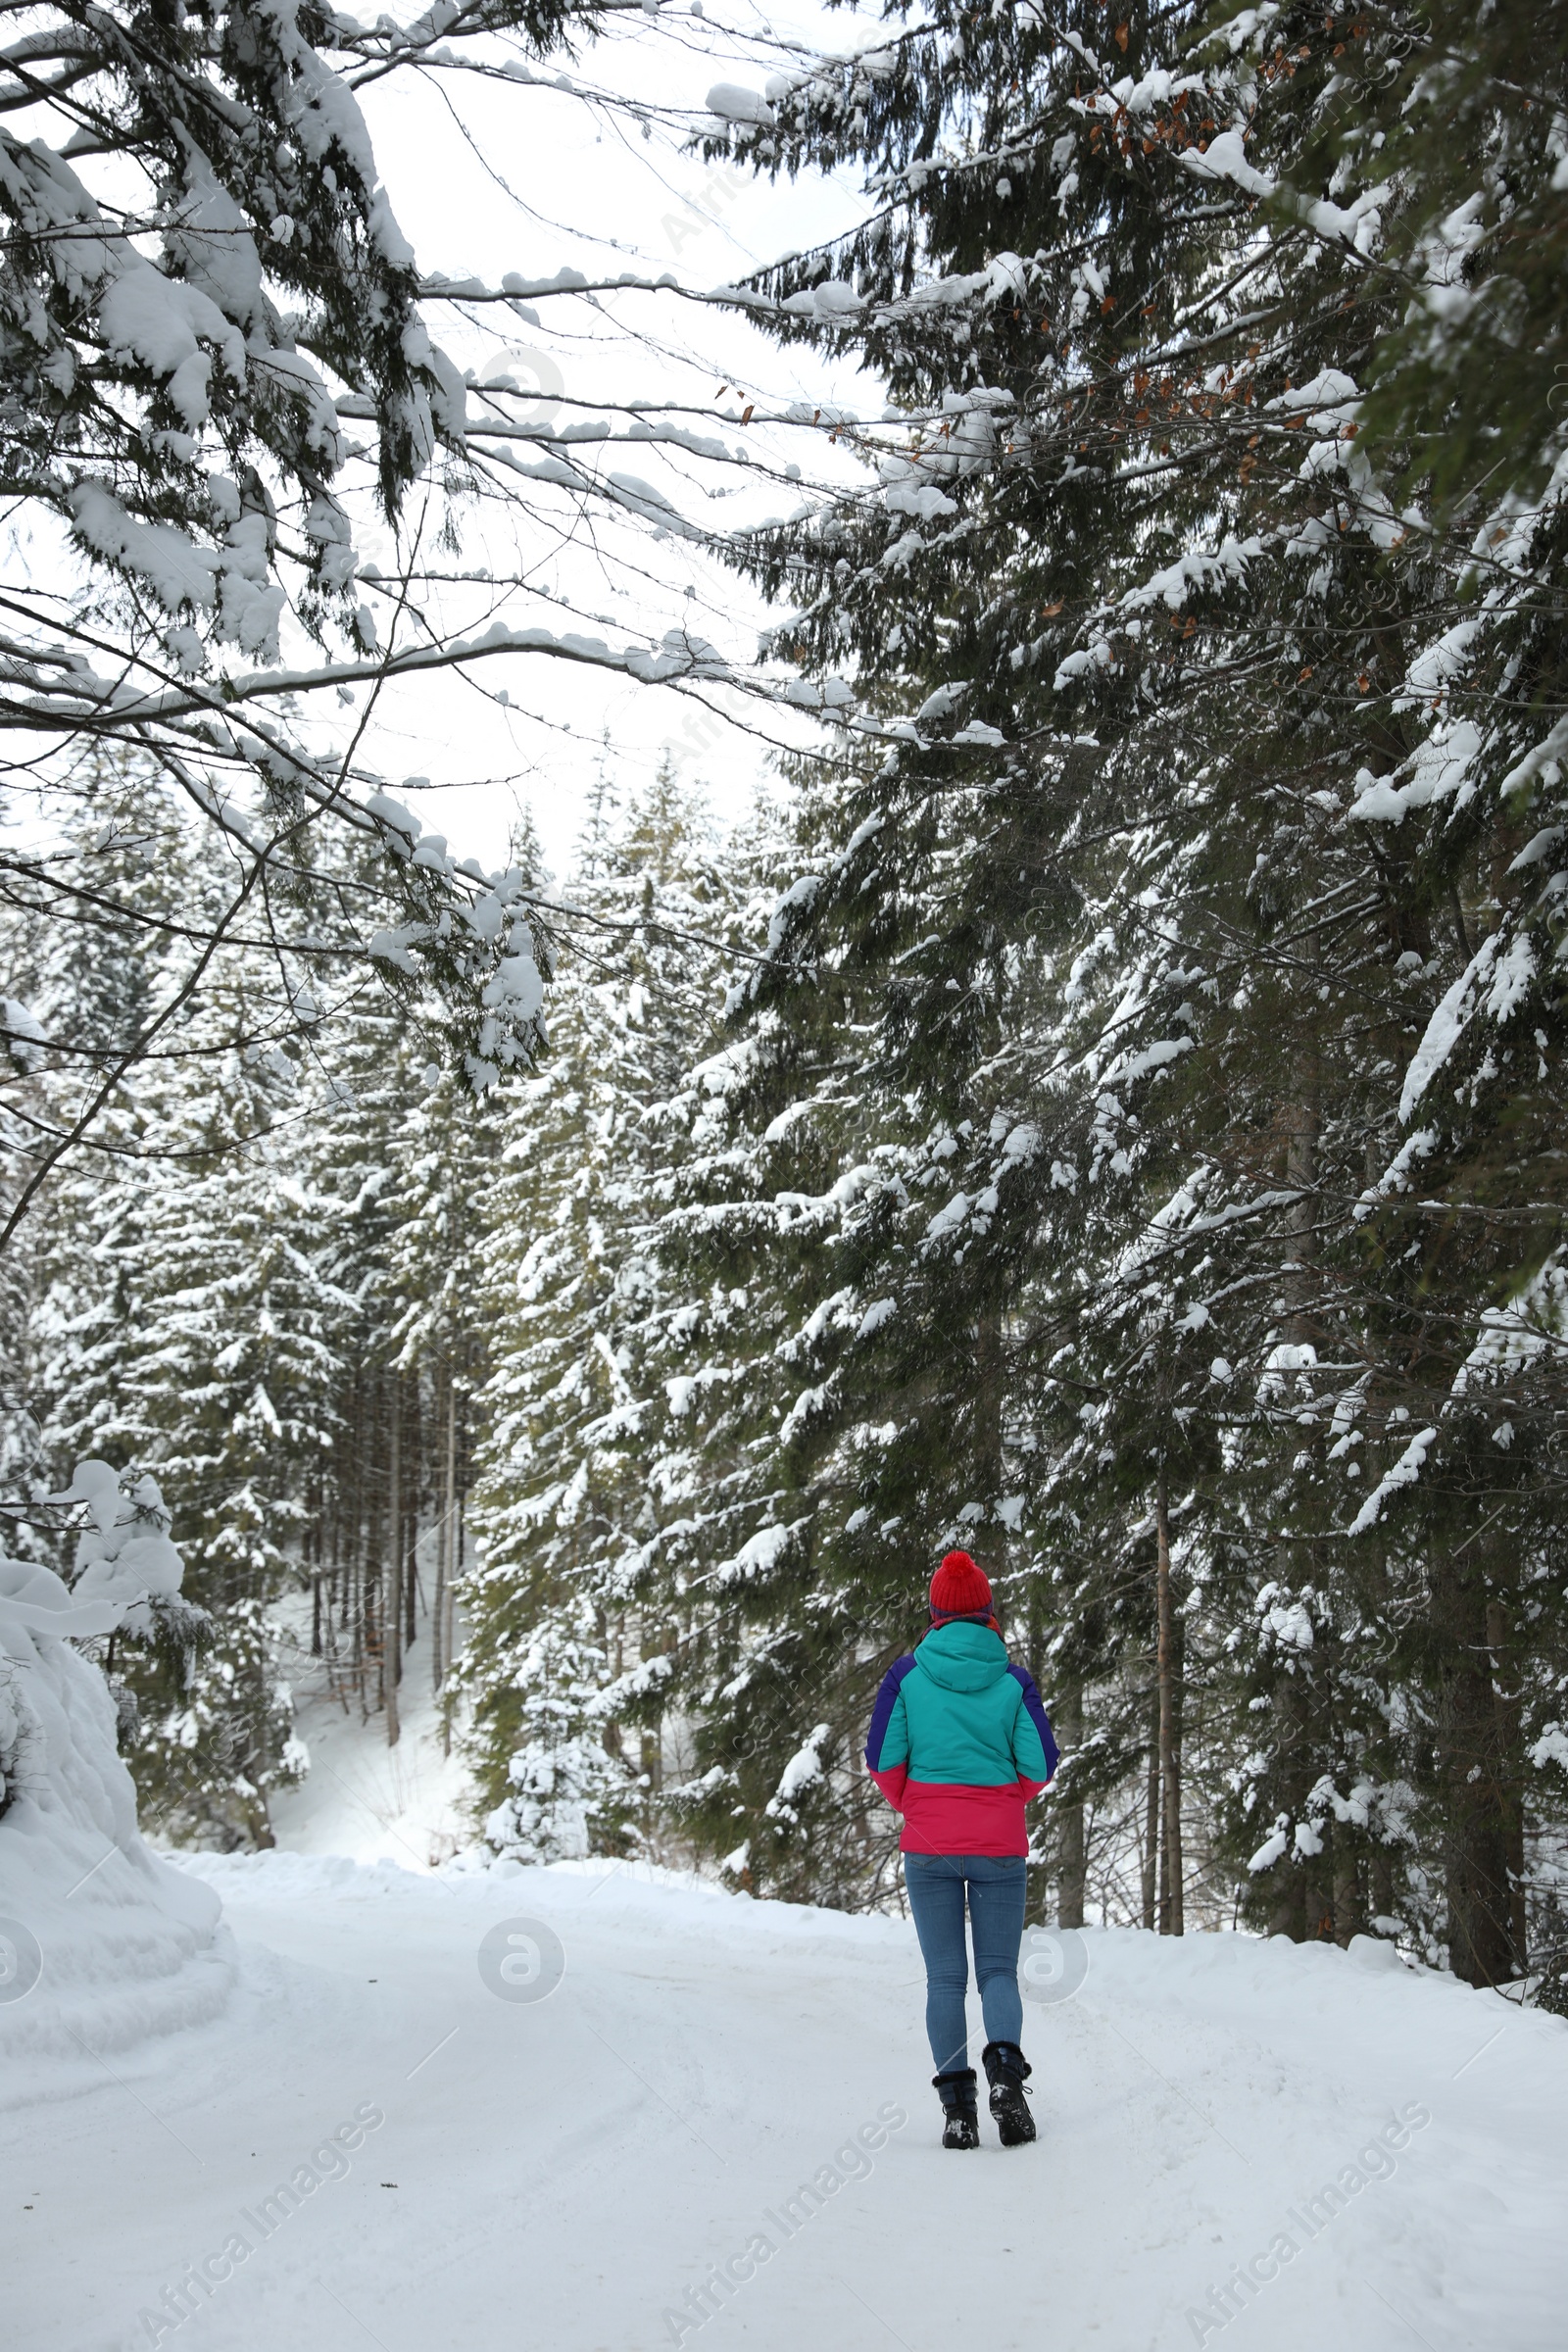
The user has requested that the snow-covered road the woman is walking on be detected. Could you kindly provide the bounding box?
[0,1853,1568,2352]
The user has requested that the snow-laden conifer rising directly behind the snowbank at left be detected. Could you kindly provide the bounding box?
[30,833,348,1844]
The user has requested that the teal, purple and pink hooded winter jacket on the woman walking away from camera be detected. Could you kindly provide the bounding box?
[865,1618,1057,1853]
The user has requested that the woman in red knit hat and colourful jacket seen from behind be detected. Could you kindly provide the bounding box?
[865,1552,1057,2147]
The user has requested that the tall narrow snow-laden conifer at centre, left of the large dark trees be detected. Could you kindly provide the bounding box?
[459,760,770,1858]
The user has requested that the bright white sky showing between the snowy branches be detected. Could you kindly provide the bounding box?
[341,12,882,872]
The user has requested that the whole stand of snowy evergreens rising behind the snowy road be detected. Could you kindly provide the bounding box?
[7,0,1568,1997]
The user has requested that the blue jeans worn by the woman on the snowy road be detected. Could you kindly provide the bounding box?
[903,1853,1025,2075]
